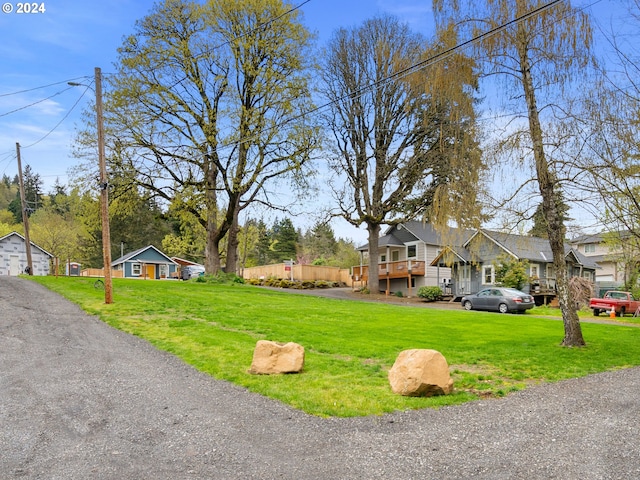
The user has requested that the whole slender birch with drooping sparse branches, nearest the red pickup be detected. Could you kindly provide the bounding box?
[434,0,591,346]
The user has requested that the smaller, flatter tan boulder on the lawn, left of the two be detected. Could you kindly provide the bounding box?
[249,340,304,375]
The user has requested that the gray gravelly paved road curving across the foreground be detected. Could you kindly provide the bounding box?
[0,277,640,480]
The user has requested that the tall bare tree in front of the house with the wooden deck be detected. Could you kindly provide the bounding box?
[322,16,480,292]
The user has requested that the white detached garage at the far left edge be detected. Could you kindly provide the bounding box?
[0,232,53,276]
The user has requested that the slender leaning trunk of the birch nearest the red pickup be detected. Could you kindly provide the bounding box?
[518,24,585,347]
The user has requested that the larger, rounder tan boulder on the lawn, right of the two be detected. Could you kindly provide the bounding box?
[389,349,453,397]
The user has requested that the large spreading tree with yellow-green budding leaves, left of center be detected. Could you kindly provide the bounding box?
[89,0,316,273]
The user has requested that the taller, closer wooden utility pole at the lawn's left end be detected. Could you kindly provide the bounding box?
[95,67,113,304]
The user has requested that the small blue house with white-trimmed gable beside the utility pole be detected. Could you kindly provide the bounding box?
[111,245,178,280]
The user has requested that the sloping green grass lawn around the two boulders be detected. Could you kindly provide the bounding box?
[30,277,640,417]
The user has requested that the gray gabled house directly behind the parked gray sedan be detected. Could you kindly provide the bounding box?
[430,229,598,304]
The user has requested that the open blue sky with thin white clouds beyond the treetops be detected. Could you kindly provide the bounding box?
[0,0,632,239]
